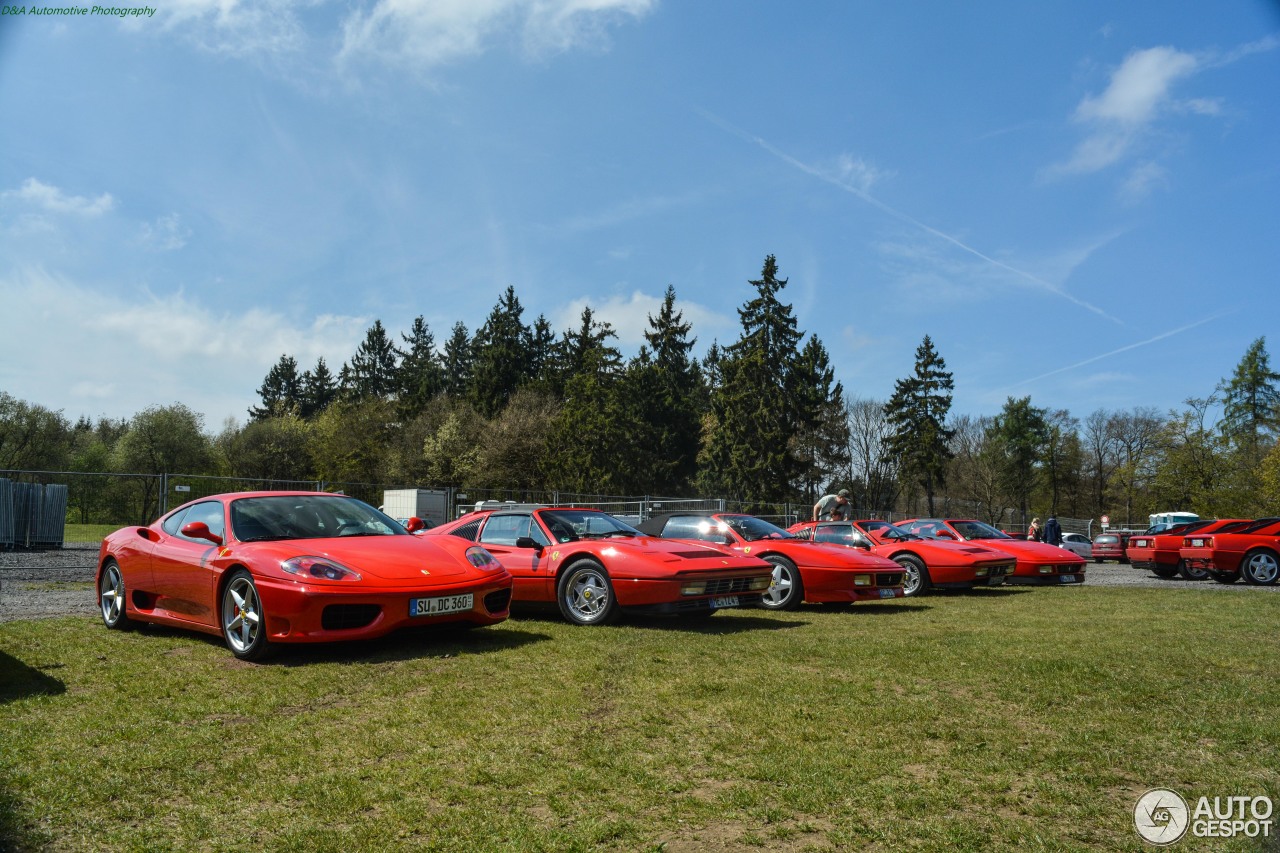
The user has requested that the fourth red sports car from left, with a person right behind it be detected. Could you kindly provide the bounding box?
[787,519,1014,596]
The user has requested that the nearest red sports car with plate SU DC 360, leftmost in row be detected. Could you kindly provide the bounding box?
[97,492,511,660]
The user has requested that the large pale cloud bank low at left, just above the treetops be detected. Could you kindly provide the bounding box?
[0,269,370,428]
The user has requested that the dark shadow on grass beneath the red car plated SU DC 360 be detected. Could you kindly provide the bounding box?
[124,625,550,666]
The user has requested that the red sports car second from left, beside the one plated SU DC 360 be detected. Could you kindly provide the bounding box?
[424,506,772,625]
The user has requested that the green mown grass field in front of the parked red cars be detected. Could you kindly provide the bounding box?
[0,588,1280,852]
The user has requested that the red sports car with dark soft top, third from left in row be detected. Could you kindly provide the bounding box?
[640,512,904,610]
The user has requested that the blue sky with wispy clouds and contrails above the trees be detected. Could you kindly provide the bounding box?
[0,0,1280,432]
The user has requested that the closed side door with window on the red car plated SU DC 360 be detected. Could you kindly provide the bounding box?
[151,501,227,625]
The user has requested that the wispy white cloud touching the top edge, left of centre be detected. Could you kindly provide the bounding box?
[339,0,655,68]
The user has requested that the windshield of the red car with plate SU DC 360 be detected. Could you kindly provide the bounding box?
[232,494,408,542]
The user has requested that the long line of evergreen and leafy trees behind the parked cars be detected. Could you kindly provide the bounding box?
[0,255,1280,520]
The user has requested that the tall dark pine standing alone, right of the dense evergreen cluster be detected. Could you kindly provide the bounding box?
[884,336,955,515]
